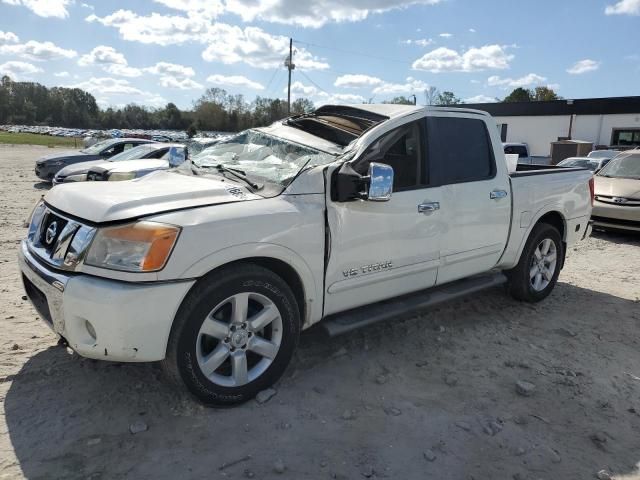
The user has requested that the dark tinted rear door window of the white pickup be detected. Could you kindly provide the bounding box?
[427,117,498,185]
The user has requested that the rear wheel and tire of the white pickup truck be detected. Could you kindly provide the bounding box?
[507,223,564,303]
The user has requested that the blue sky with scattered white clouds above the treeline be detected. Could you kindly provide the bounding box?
[0,0,640,109]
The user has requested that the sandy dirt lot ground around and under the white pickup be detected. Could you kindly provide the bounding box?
[0,146,640,480]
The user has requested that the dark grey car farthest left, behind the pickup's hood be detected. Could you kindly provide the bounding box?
[35,138,153,182]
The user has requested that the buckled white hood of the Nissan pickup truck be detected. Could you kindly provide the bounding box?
[45,171,262,223]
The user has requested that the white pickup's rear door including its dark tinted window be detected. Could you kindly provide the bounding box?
[427,112,511,284]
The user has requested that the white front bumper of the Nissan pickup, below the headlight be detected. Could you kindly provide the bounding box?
[19,241,194,362]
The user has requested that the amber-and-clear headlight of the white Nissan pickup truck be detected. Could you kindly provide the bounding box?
[85,221,180,272]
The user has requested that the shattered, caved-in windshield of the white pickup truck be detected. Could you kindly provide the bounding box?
[192,130,335,186]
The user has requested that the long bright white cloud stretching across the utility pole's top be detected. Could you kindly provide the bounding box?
[85,9,329,70]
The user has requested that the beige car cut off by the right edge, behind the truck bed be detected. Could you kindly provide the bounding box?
[591,150,640,232]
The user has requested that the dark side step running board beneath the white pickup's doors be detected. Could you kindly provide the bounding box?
[320,273,507,337]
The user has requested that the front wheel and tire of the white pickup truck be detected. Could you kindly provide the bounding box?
[163,264,301,407]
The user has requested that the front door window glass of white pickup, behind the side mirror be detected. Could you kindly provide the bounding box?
[354,122,425,191]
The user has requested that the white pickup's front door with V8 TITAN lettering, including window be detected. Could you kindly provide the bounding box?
[324,120,442,315]
